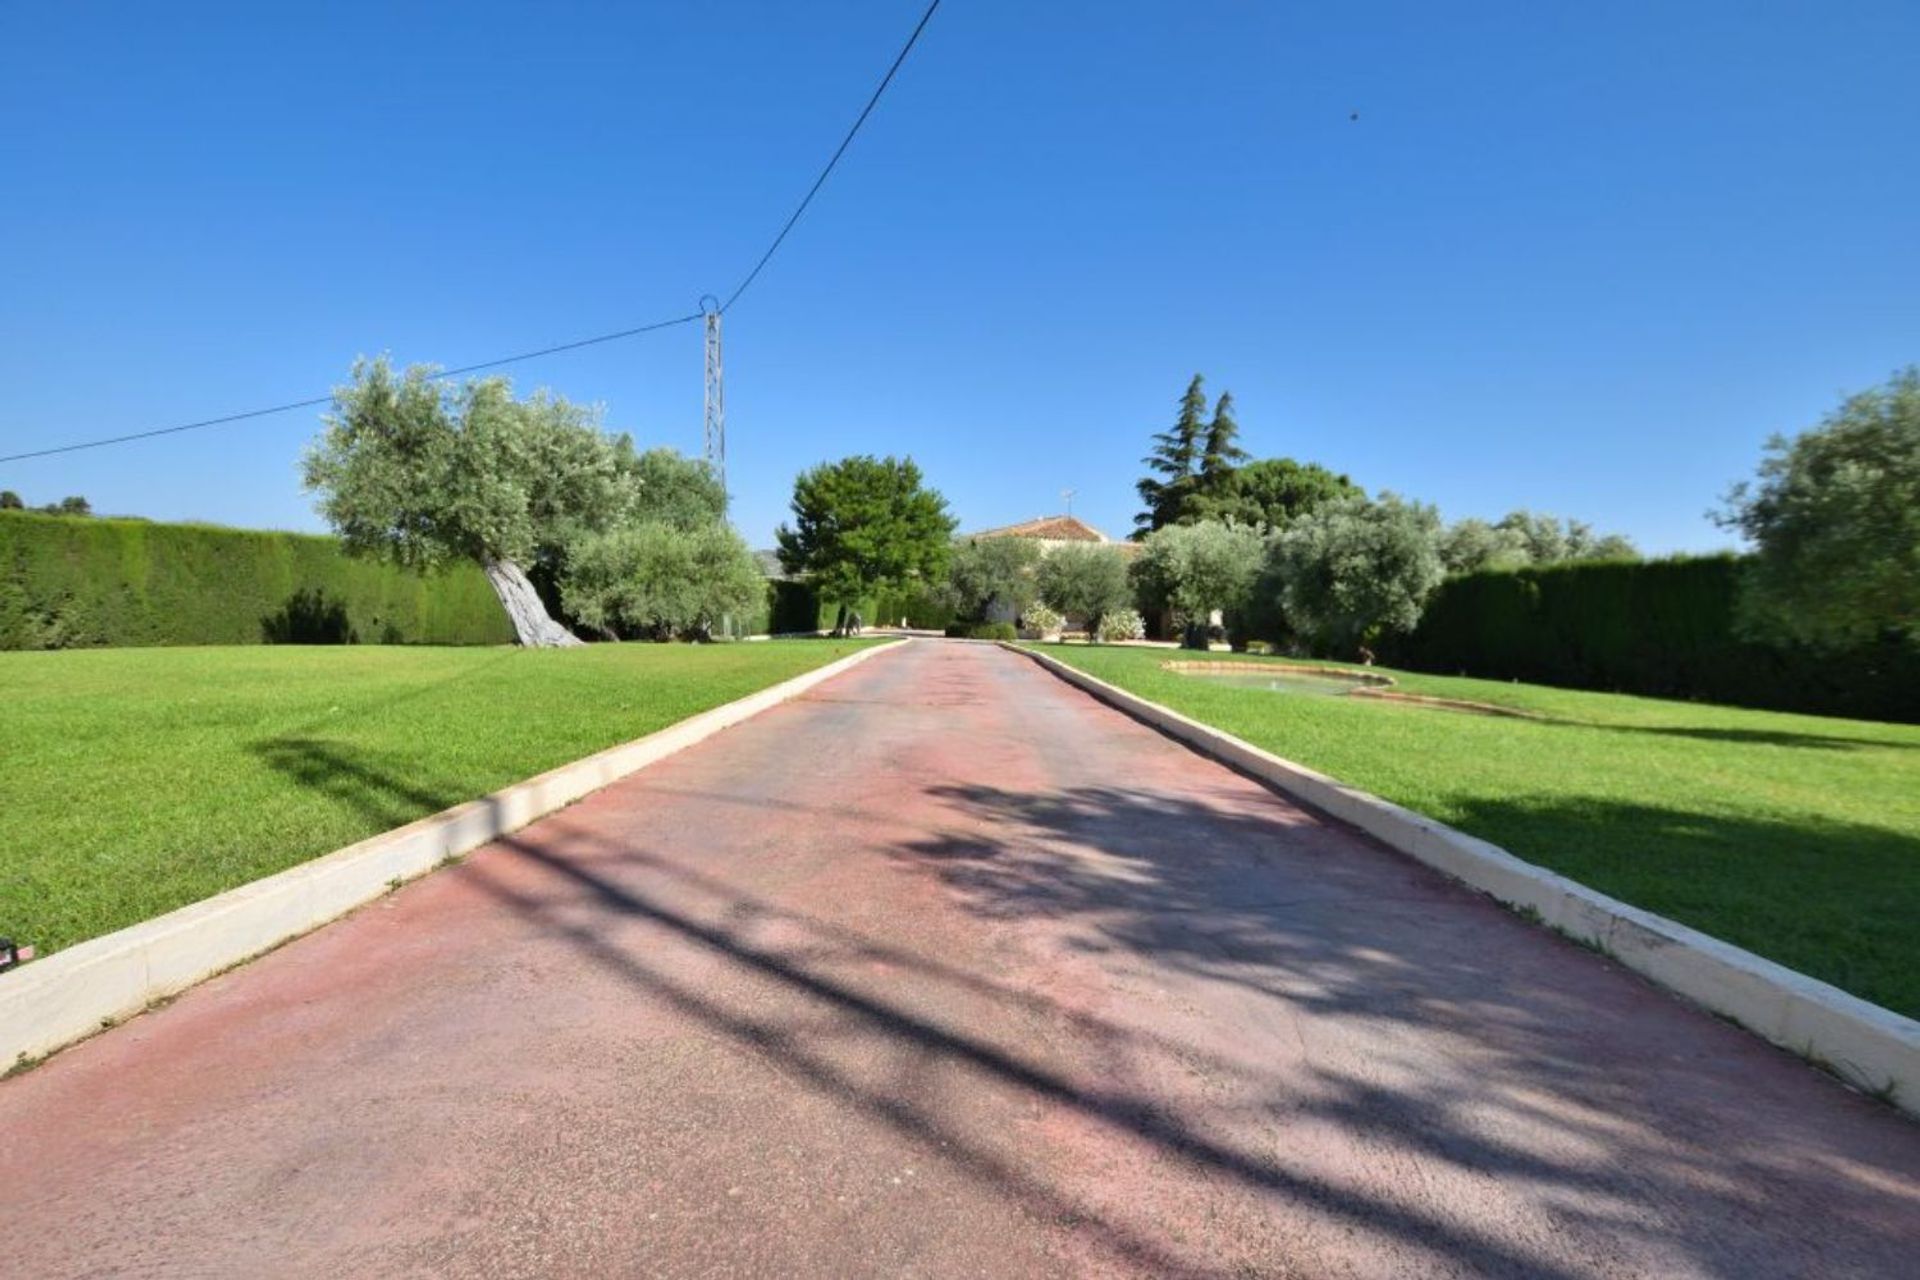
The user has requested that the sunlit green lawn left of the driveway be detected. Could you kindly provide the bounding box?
[0,641,866,954]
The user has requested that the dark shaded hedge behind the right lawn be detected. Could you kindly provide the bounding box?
[1382,555,1920,722]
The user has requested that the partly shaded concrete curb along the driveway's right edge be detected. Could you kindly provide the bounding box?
[1006,645,1920,1115]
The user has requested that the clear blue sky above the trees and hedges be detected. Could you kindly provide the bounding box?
[0,0,1920,551]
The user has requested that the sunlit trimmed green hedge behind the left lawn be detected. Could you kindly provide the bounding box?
[0,510,513,649]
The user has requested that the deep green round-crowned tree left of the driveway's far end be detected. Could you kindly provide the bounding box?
[774,455,954,631]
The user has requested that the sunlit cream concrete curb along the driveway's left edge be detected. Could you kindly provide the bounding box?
[0,641,908,1067]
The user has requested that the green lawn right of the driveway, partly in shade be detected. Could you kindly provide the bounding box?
[1041,645,1920,1017]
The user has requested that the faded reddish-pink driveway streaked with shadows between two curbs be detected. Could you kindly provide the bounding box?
[0,643,1920,1278]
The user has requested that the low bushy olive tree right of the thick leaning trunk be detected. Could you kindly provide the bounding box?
[561,520,766,641]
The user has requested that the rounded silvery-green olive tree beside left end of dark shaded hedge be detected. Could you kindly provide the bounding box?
[1273,493,1446,658]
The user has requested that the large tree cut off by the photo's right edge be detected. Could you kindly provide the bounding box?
[1716,367,1920,645]
